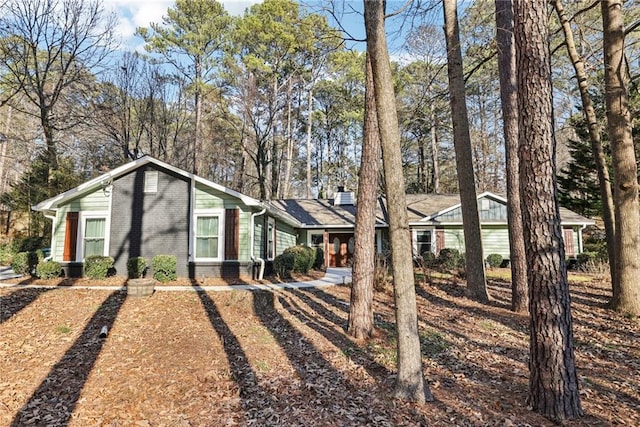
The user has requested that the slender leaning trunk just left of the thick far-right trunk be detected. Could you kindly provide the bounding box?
[553,0,617,286]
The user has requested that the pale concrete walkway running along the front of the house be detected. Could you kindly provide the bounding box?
[0,267,351,292]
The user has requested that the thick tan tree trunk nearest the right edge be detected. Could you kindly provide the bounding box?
[600,0,640,316]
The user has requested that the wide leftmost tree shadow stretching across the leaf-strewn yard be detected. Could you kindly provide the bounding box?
[11,291,126,427]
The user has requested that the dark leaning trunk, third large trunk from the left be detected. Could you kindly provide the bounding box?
[444,0,489,302]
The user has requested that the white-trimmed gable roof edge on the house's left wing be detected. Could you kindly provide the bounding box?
[32,156,299,226]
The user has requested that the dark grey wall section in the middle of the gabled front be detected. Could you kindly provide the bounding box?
[109,165,191,277]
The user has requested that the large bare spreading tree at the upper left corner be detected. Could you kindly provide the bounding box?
[0,0,116,176]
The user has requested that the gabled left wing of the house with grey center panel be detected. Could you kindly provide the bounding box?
[34,157,300,279]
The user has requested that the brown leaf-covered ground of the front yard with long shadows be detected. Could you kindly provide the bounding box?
[0,272,640,427]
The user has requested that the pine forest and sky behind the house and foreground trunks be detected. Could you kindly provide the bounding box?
[0,0,640,237]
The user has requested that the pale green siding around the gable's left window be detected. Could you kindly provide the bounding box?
[51,189,111,261]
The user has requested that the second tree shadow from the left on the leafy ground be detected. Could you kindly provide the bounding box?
[192,291,278,425]
